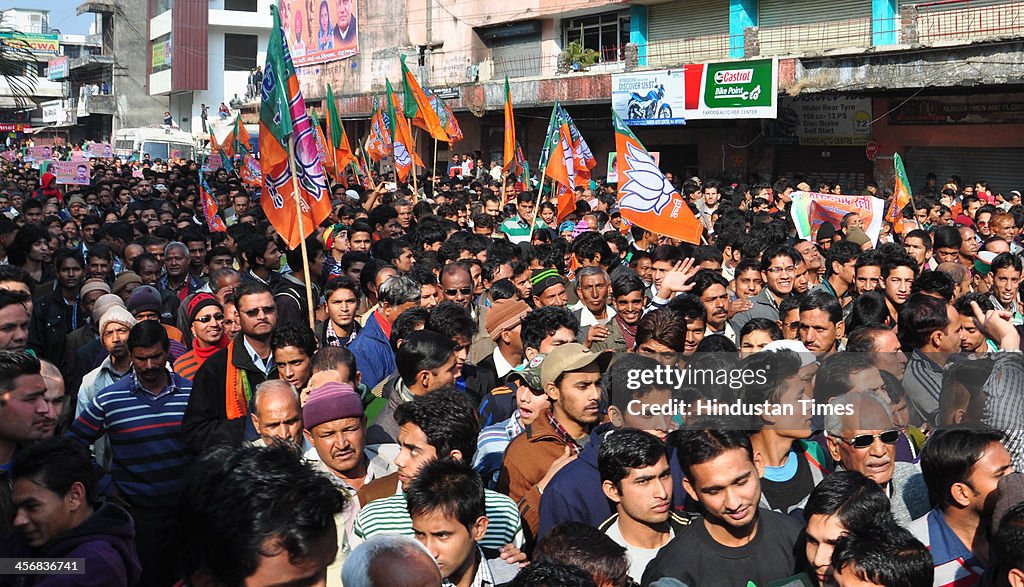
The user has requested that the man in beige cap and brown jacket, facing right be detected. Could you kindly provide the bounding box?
[498,342,611,540]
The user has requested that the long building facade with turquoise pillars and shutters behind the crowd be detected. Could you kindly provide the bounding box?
[299,0,1024,192]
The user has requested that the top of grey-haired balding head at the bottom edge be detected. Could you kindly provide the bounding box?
[341,534,441,587]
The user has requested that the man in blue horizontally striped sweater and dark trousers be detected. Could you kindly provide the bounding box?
[68,320,193,585]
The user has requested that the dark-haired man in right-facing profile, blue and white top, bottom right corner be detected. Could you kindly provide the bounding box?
[909,428,1014,587]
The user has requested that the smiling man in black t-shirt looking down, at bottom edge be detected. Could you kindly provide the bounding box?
[642,426,801,585]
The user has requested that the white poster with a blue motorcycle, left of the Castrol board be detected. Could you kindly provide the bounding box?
[611,70,686,126]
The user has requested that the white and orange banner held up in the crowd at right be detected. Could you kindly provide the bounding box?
[790,192,885,245]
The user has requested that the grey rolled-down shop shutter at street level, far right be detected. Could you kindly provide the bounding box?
[903,146,1024,194]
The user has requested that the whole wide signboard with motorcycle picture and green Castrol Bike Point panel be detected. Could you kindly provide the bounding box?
[611,59,778,126]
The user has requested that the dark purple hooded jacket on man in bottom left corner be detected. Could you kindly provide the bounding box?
[0,503,142,587]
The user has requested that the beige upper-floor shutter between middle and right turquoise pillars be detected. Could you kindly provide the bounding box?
[758,0,871,55]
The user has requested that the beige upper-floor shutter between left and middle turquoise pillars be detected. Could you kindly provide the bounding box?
[647,0,729,67]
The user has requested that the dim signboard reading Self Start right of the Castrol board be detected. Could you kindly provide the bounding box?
[765,94,871,146]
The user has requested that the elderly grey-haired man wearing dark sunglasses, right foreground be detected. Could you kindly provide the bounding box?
[824,391,931,526]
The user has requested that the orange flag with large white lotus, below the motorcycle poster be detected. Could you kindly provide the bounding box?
[611,111,703,245]
